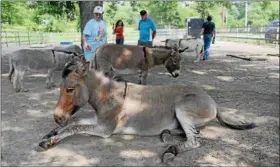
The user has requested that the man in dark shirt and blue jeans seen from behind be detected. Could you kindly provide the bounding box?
[200,16,216,60]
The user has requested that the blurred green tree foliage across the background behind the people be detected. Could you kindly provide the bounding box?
[1,1,279,32]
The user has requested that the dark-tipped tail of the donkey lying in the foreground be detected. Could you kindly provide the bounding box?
[216,112,256,130]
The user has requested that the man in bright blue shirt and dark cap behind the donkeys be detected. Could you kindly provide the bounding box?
[138,10,156,47]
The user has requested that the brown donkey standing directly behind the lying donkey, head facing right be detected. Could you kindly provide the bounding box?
[94,44,188,85]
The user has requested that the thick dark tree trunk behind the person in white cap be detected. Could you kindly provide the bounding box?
[79,1,103,49]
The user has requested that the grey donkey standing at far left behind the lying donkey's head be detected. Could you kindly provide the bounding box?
[8,45,82,92]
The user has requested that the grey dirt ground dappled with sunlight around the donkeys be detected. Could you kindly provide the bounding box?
[1,41,279,166]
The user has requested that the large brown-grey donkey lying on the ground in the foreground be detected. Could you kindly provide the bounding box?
[38,62,255,162]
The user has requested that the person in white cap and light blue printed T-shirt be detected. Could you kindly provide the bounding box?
[83,6,107,66]
